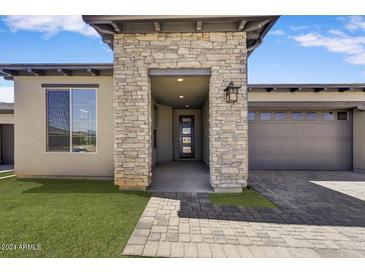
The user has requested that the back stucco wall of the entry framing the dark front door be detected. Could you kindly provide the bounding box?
[174,109,202,160]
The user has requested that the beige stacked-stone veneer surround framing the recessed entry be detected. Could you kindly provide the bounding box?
[114,32,248,191]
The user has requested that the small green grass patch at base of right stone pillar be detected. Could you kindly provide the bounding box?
[209,187,277,208]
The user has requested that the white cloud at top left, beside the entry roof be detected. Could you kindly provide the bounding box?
[4,15,98,37]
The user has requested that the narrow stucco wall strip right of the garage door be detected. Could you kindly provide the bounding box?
[353,110,365,172]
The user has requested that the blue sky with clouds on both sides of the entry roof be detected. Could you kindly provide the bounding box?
[0,16,365,101]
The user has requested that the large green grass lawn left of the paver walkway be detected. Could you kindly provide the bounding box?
[0,178,150,257]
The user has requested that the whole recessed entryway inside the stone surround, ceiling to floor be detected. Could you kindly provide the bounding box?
[149,69,212,192]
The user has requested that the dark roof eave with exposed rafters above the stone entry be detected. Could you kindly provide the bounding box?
[83,15,280,54]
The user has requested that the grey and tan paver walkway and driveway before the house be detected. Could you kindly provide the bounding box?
[123,171,365,257]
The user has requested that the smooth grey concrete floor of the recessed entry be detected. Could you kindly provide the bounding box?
[150,161,213,193]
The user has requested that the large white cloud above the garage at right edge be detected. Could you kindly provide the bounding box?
[291,17,365,65]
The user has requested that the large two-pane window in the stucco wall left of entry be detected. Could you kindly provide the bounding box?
[46,89,96,152]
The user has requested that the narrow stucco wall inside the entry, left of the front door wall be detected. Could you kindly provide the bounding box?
[157,105,173,163]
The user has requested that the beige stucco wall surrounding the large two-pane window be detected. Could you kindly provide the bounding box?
[14,76,113,177]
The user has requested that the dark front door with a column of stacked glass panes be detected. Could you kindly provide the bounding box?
[179,115,194,158]
